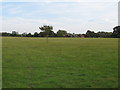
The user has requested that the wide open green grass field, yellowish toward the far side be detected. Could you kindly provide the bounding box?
[2,37,118,88]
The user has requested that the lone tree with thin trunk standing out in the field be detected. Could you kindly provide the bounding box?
[39,25,53,42]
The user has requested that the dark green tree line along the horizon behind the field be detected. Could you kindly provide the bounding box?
[1,25,120,38]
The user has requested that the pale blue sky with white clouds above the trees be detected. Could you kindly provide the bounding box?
[0,0,118,33]
